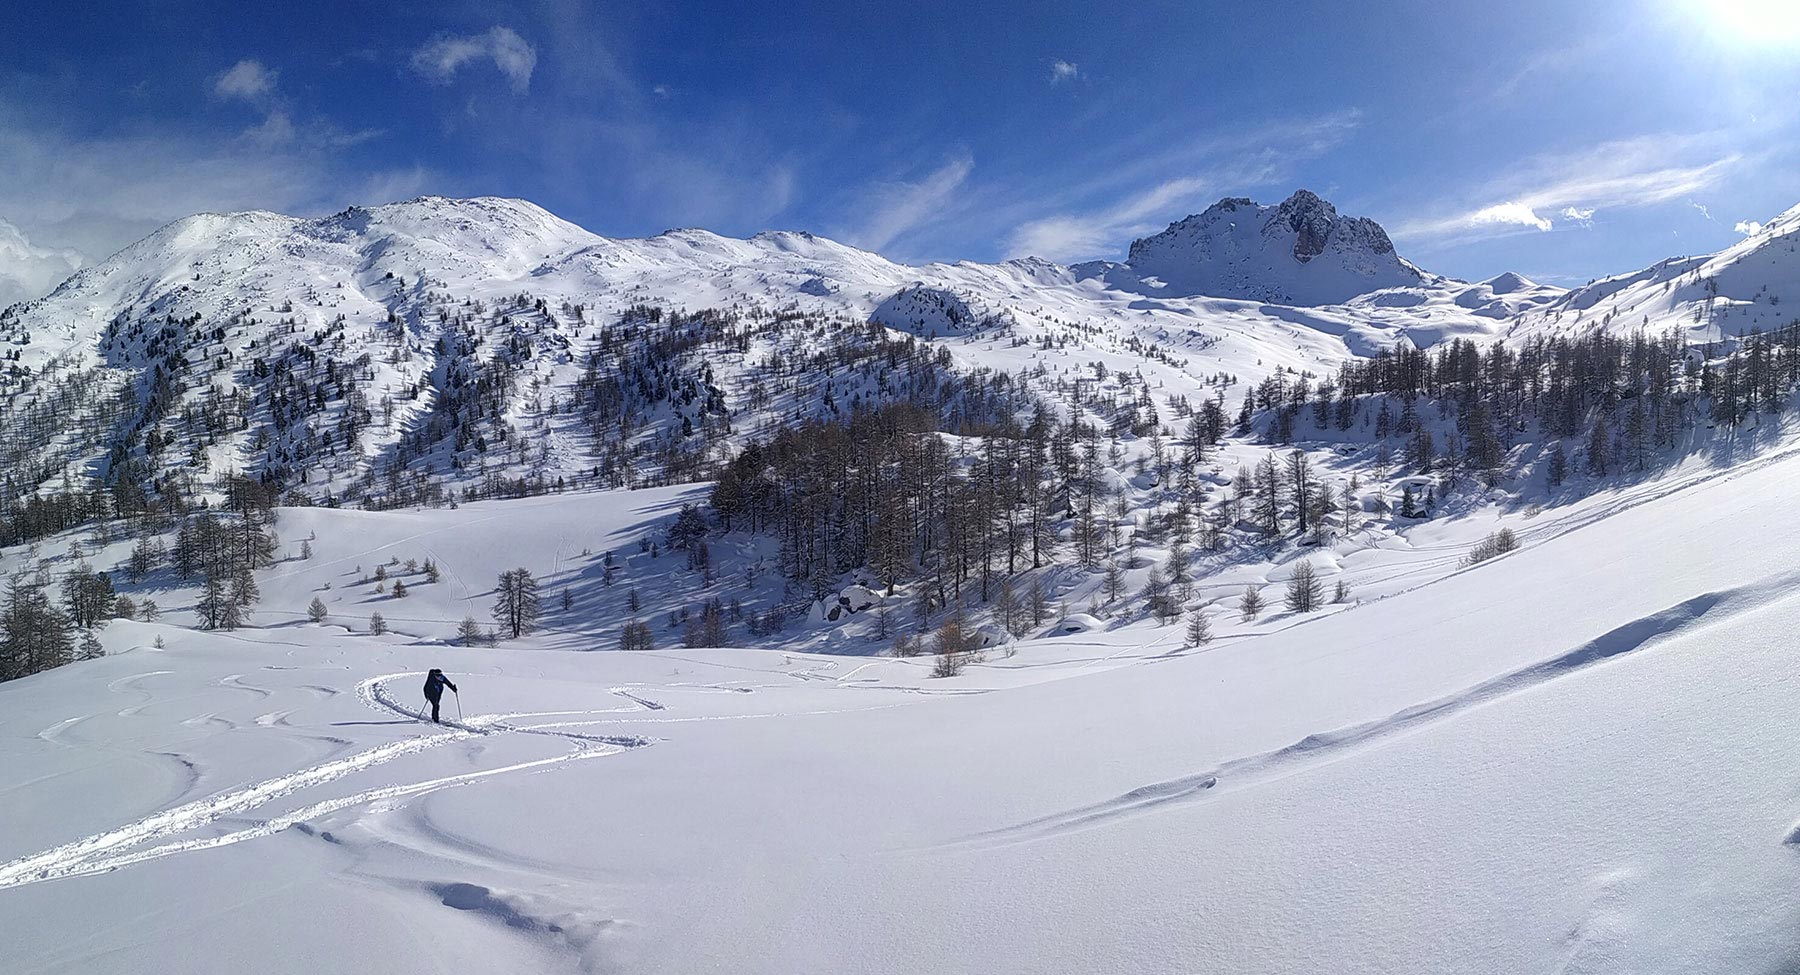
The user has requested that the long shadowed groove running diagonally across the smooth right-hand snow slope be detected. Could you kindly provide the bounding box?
[927,570,1800,849]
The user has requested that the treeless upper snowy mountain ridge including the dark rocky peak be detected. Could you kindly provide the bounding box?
[9,191,1533,365]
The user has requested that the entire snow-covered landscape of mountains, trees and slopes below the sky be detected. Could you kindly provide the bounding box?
[0,185,1800,973]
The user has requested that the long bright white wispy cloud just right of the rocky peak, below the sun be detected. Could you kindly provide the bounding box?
[1395,137,1742,239]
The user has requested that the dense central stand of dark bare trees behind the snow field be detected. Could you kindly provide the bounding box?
[711,374,1217,606]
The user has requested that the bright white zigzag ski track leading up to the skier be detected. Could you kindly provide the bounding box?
[0,671,650,890]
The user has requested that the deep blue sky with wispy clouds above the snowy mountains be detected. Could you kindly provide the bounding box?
[0,0,1800,284]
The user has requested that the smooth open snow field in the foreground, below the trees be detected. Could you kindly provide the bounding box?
[10,435,1800,975]
